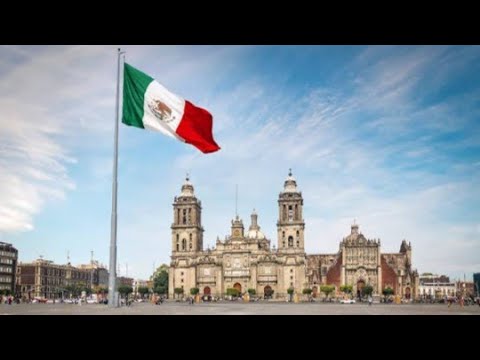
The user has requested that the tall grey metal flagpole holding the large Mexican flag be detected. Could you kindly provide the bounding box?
[108,48,125,308]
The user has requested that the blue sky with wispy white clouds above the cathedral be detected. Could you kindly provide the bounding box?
[0,46,480,278]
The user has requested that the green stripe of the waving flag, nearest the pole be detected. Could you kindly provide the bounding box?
[122,63,153,129]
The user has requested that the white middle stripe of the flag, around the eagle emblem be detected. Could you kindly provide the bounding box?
[142,80,185,141]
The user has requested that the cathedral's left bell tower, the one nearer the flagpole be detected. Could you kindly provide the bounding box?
[171,174,203,255]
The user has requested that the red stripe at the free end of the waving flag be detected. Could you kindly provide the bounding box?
[176,100,220,153]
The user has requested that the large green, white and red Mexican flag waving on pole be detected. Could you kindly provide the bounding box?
[122,64,220,153]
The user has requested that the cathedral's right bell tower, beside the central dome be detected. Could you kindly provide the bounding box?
[277,169,305,253]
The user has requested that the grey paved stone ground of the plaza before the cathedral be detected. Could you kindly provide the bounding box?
[0,302,480,315]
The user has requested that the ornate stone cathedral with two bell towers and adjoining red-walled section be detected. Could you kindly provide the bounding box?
[168,171,418,299]
